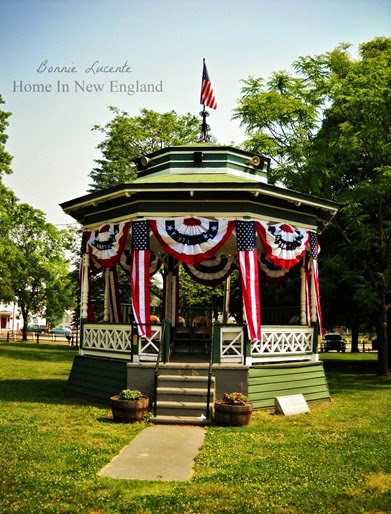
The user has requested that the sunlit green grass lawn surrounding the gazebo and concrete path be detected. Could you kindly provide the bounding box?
[0,342,391,514]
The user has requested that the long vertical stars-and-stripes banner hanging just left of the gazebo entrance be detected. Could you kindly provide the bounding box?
[130,220,151,337]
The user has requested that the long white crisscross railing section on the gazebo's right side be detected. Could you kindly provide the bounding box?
[251,326,314,363]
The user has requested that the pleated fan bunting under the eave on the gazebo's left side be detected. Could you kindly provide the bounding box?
[87,222,130,268]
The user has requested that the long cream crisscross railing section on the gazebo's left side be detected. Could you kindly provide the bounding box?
[81,323,132,360]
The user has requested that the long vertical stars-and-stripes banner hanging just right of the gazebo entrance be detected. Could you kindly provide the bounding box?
[236,220,261,341]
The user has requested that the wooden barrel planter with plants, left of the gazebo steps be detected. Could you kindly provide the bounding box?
[110,389,149,423]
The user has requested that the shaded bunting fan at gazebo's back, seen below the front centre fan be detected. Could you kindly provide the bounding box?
[183,255,234,286]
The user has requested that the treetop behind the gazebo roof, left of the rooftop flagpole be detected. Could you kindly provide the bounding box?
[89,107,200,192]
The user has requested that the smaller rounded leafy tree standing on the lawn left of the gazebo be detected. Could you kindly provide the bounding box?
[4,203,74,339]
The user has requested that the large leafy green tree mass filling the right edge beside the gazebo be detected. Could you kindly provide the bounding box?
[234,38,391,375]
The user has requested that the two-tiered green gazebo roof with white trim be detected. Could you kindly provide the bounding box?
[61,143,338,230]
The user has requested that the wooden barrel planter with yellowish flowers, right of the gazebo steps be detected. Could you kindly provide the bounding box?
[214,392,253,427]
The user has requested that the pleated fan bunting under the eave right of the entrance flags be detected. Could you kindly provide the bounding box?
[256,221,309,269]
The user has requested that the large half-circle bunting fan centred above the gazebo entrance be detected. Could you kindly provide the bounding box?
[150,217,234,265]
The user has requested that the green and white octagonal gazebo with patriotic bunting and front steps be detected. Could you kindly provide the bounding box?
[61,142,338,423]
